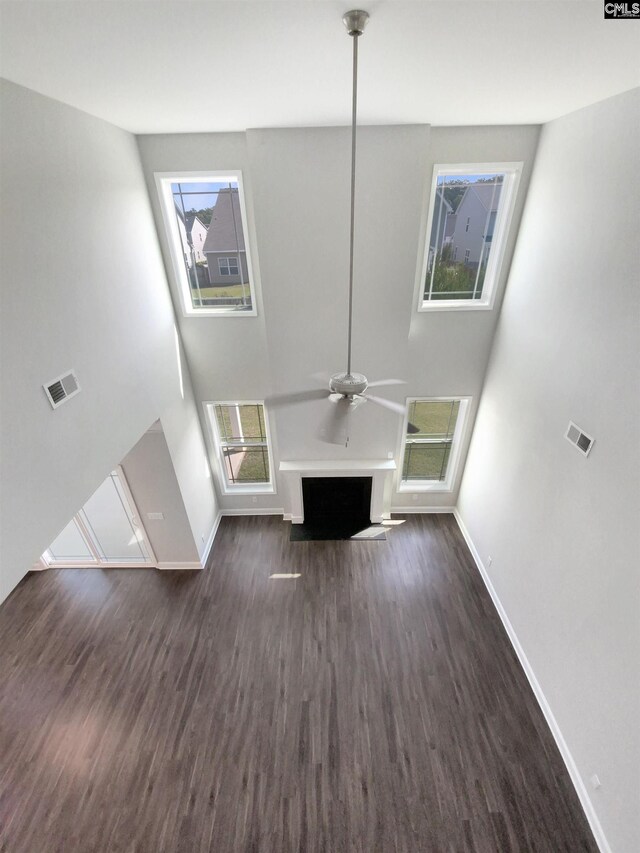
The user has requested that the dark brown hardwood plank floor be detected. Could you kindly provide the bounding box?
[0,515,597,853]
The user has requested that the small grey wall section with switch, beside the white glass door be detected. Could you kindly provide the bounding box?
[121,422,199,564]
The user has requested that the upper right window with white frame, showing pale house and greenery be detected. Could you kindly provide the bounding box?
[419,163,522,311]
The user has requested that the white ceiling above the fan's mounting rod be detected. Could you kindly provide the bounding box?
[0,0,640,133]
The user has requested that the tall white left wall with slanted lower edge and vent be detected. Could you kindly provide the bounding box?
[0,82,216,600]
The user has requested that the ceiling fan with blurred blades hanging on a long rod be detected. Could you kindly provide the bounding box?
[266,9,419,445]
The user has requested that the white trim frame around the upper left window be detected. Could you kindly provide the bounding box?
[154,169,258,317]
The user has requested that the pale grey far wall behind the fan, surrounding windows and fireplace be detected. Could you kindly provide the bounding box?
[138,125,539,509]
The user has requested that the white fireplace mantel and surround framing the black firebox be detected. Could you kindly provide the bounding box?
[280,459,396,524]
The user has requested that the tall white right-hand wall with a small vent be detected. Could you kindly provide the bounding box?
[459,90,640,853]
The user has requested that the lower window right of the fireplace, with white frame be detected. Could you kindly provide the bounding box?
[401,397,468,491]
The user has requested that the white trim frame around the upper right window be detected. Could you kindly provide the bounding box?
[416,162,524,312]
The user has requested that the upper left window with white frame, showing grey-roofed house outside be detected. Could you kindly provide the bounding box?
[156,173,256,315]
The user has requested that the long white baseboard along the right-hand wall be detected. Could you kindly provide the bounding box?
[453,507,611,853]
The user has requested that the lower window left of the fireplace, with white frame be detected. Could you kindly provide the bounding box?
[207,402,272,491]
